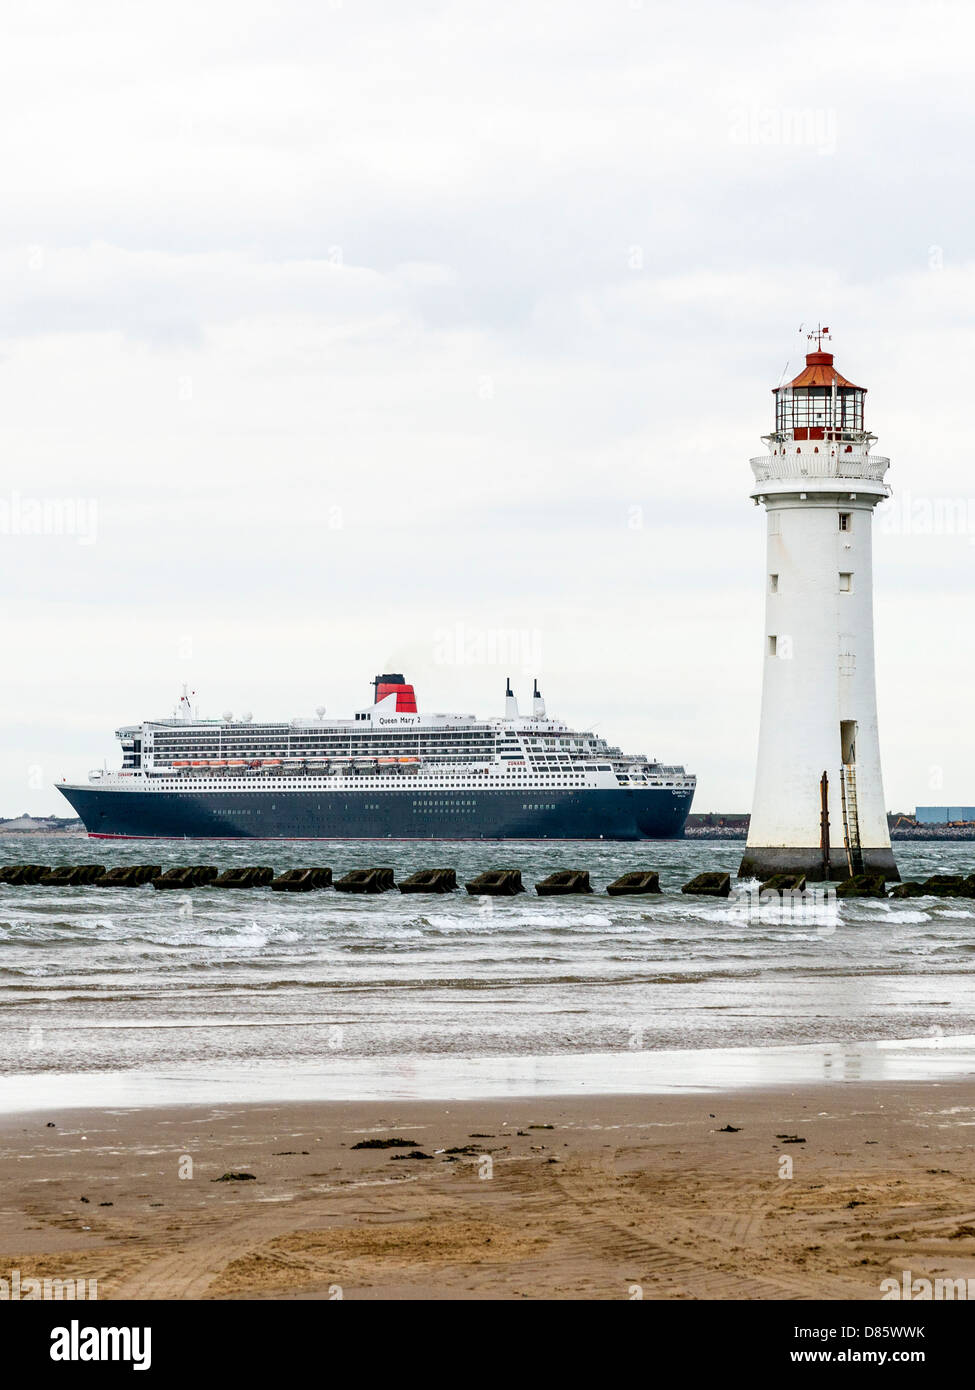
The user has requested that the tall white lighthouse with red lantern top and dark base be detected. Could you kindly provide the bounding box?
[739,328,900,880]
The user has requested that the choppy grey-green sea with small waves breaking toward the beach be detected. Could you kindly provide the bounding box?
[0,835,975,1111]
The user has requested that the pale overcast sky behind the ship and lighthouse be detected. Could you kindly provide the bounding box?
[0,0,975,816]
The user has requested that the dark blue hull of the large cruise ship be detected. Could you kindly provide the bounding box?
[58,787,691,840]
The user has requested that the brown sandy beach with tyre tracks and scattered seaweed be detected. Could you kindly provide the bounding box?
[0,1080,975,1300]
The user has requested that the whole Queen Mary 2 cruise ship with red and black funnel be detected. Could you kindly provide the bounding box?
[57,674,695,840]
